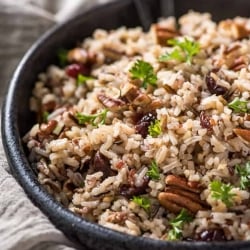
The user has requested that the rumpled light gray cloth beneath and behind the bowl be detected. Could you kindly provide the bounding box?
[0,0,108,250]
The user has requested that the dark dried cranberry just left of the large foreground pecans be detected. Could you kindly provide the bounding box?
[119,176,149,199]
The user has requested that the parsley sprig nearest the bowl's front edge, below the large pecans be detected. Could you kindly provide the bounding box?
[167,209,193,240]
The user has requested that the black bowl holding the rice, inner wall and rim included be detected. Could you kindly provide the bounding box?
[2,0,250,250]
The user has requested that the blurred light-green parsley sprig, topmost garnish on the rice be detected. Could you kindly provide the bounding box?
[159,37,200,64]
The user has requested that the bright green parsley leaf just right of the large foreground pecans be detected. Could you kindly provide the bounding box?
[210,180,236,207]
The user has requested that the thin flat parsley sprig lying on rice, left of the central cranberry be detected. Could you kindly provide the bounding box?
[76,109,108,126]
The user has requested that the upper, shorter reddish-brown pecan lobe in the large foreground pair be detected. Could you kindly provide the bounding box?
[165,175,200,193]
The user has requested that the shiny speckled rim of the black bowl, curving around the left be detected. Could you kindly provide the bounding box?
[1,0,250,249]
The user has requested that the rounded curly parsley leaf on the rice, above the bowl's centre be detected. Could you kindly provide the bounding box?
[129,60,157,89]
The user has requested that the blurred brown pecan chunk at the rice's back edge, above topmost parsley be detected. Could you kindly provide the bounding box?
[154,24,179,46]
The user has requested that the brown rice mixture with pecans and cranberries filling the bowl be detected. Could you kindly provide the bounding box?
[23,12,250,241]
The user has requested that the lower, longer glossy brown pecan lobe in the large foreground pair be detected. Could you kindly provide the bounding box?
[158,192,203,213]
